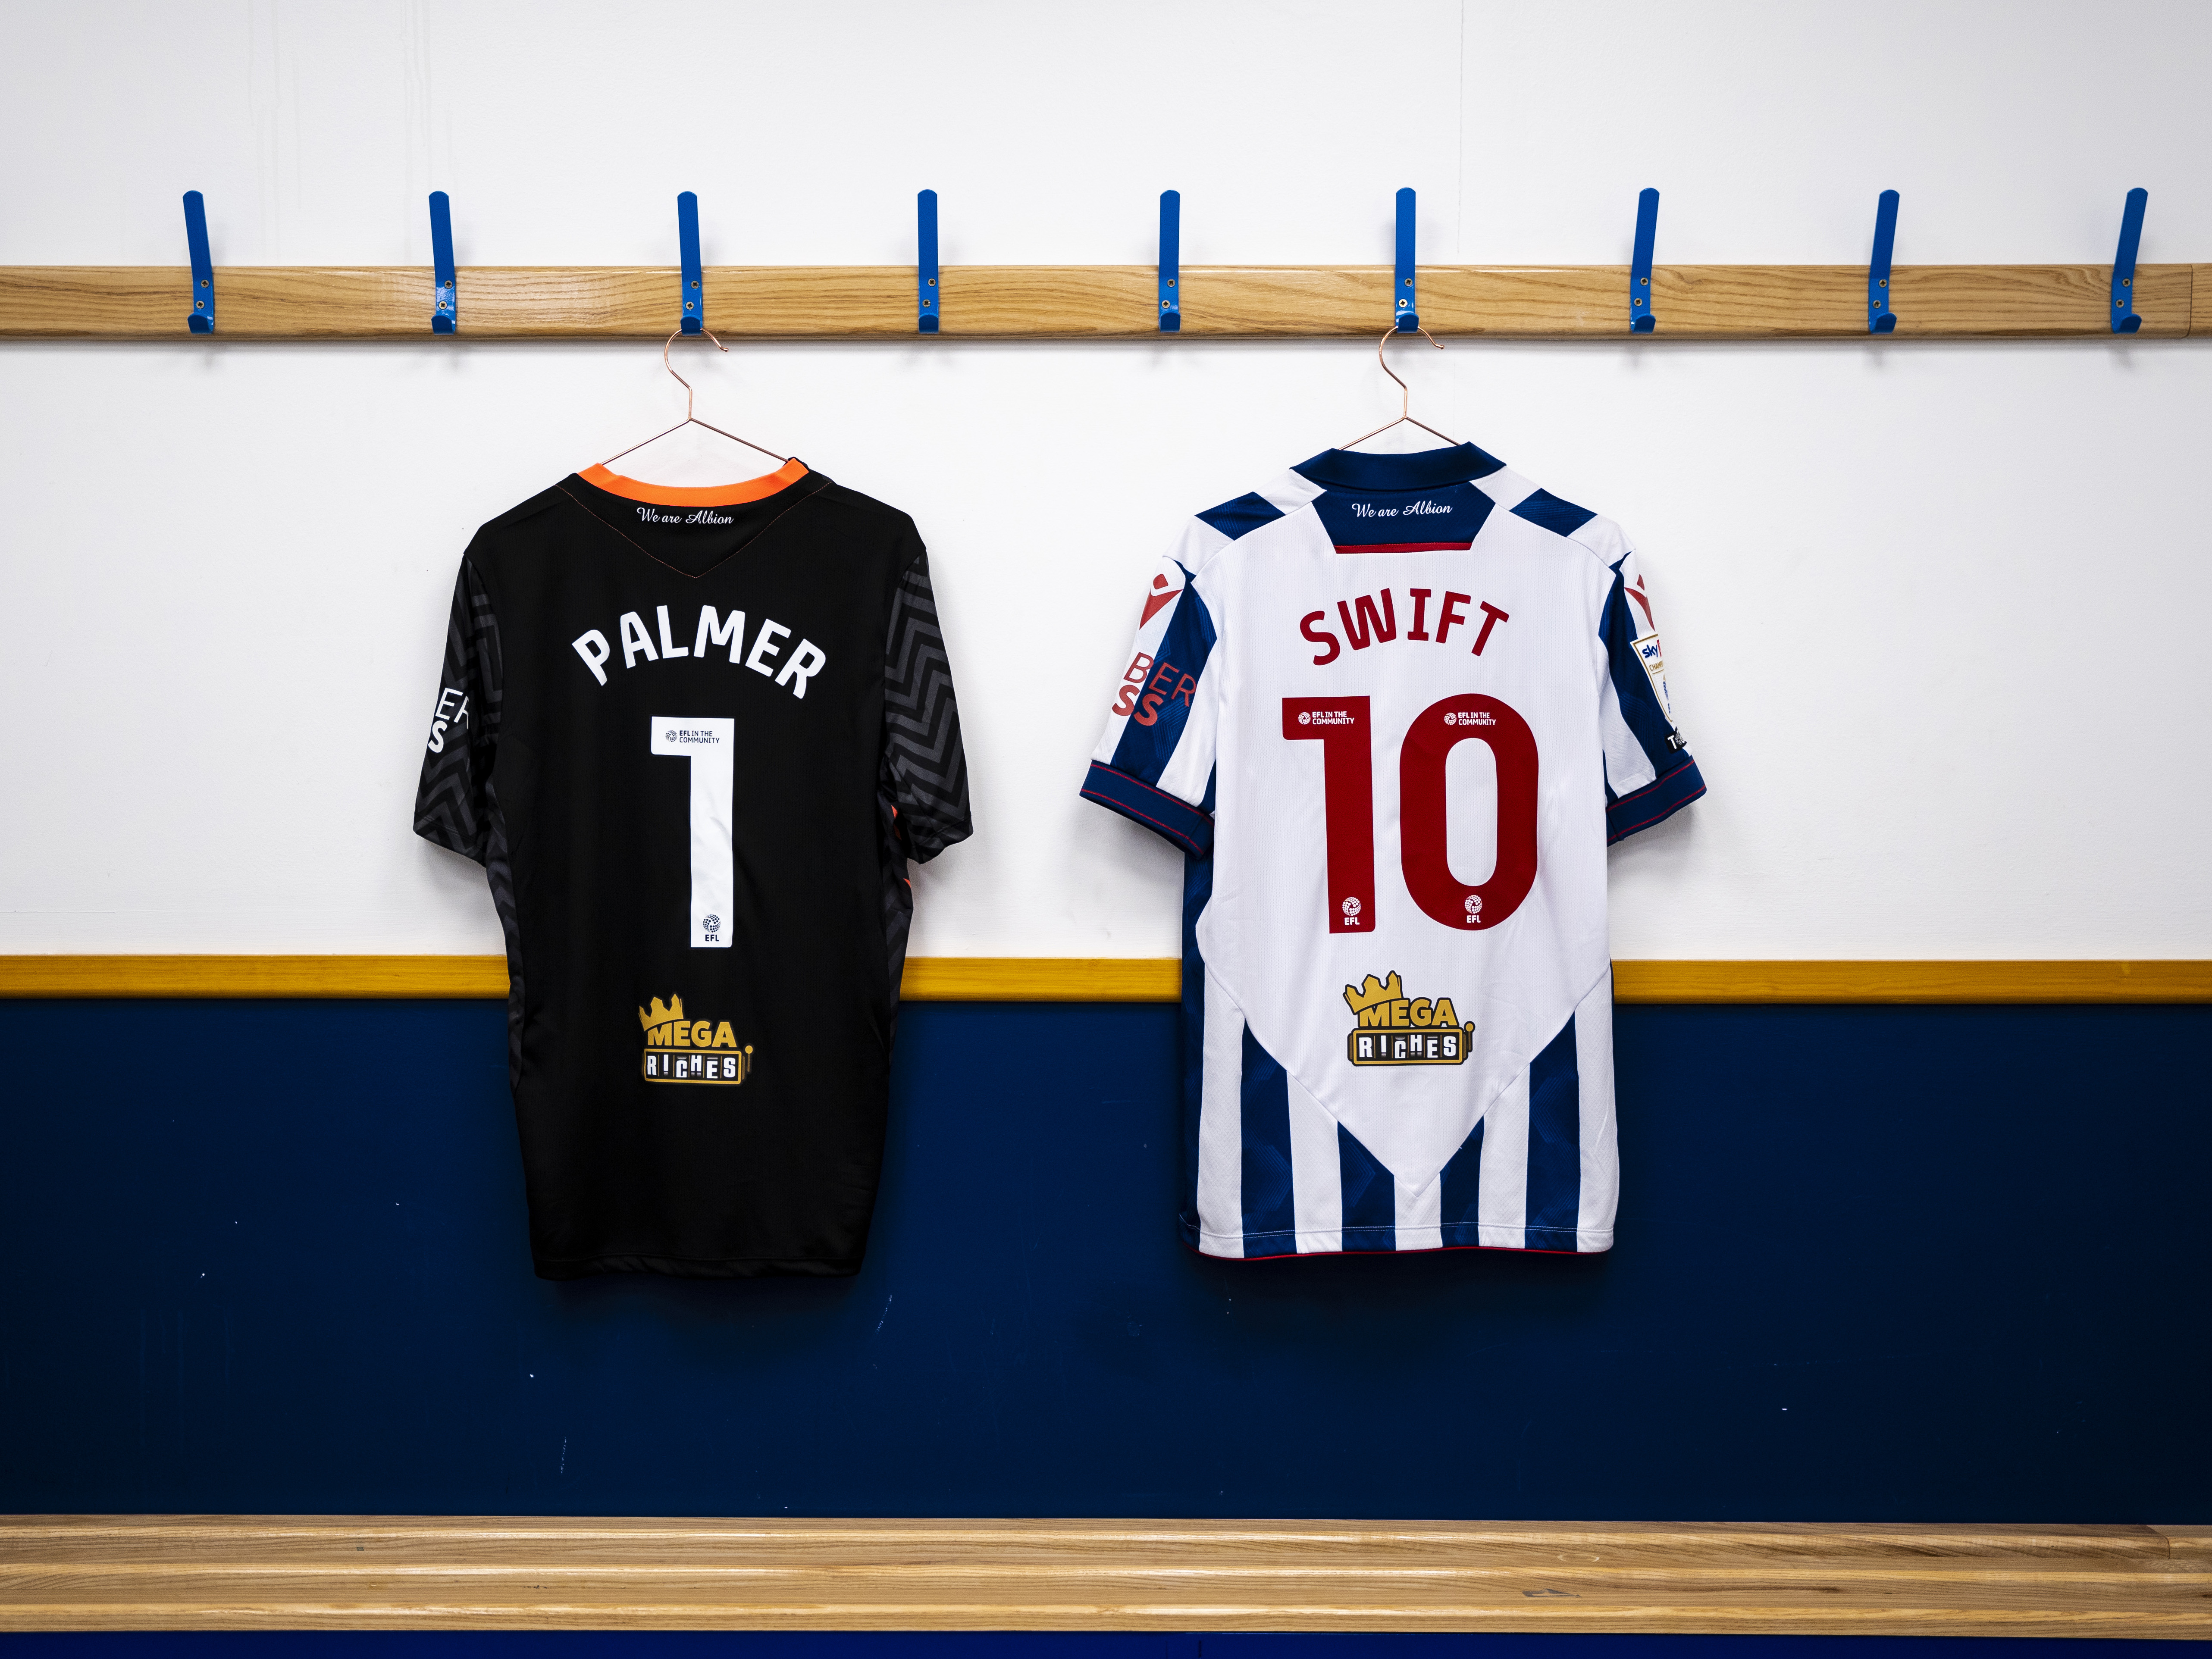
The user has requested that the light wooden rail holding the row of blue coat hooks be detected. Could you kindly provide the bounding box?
[0,266,2212,341]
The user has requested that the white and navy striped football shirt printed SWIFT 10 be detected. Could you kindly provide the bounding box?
[1084,444,1705,1256]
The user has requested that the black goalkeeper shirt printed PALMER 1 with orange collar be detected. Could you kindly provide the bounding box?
[416,460,969,1279]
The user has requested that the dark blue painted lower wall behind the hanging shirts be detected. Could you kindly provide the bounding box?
[0,1002,2212,1522]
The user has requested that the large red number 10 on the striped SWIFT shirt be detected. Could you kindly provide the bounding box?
[1283,692,1537,933]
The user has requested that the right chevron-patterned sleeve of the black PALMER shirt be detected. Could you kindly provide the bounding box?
[883,551,971,863]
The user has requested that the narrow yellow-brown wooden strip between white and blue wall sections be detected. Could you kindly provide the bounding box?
[0,955,2212,1002]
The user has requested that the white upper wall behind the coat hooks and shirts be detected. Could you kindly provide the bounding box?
[0,0,2212,958]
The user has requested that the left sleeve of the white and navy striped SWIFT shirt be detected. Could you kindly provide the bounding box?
[1082,548,1221,858]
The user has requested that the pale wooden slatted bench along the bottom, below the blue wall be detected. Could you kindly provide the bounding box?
[0,1515,2212,1639]
